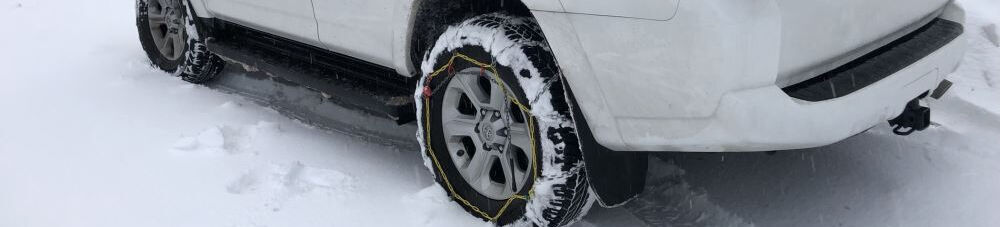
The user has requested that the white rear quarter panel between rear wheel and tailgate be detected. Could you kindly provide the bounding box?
[535,0,781,150]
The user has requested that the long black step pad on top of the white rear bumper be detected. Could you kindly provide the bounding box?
[782,18,965,102]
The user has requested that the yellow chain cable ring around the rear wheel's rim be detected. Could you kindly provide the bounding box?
[424,53,538,223]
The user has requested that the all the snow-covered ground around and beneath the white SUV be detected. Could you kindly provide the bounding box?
[0,0,1000,227]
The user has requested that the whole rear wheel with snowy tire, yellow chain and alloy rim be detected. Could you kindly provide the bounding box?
[415,13,595,226]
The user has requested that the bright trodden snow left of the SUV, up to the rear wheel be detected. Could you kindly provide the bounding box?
[0,0,486,227]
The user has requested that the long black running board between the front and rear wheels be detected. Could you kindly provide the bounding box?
[202,19,416,125]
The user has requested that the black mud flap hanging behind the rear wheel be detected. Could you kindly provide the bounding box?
[566,85,649,207]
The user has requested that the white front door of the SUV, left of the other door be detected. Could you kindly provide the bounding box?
[205,0,321,46]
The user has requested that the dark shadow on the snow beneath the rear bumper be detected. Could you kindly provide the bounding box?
[584,129,946,226]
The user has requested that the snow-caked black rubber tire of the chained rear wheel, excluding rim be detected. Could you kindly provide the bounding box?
[414,13,595,226]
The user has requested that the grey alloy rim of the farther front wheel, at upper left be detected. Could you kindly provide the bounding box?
[146,0,186,61]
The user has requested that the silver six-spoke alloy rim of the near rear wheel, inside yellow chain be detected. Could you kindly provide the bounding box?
[441,68,533,200]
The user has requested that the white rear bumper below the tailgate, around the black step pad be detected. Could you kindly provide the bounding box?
[618,36,965,152]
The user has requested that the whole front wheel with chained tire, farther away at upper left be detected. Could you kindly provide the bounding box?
[136,0,225,83]
